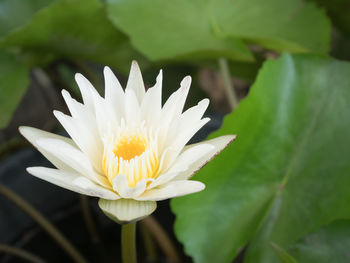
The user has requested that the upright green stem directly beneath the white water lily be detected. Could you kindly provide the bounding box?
[122,222,136,263]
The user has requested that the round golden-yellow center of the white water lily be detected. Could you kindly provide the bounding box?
[113,135,147,160]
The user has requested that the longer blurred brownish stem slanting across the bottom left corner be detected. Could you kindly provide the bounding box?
[0,184,87,263]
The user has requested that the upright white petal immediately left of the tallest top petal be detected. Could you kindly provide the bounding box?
[103,67,125,120]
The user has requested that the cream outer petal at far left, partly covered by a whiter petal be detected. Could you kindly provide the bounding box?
[19,126,75,171]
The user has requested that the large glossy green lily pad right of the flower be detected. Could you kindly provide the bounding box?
[172,55,350,263]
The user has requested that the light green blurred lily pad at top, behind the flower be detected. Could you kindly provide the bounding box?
[107,0,330,60]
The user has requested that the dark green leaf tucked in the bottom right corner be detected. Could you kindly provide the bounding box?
[290,220,350,263]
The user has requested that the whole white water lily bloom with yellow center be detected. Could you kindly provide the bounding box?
[20,62,235,225]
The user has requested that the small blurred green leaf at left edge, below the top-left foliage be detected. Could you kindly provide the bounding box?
[0,52,29,129]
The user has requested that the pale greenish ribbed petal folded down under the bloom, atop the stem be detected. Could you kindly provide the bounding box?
[98,199,157,224]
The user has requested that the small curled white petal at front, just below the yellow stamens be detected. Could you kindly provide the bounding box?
[113,174,153,198]
